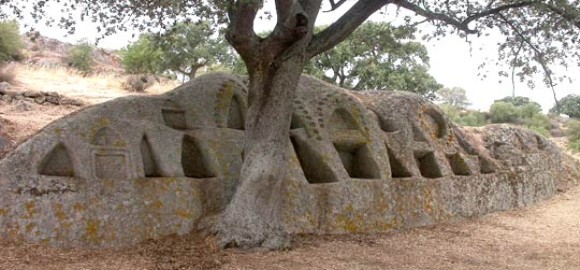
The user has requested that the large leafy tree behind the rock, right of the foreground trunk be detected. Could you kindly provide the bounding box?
[305,22,441,98]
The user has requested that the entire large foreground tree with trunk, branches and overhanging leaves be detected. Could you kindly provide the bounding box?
[0,0,580,248]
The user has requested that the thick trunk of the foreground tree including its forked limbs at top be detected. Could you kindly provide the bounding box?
[207,0,320,249]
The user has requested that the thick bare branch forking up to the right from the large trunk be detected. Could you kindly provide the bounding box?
[307,0,395,58]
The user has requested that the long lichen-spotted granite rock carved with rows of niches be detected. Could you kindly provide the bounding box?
[0,74,562,247]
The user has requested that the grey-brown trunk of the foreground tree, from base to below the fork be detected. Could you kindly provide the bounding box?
[218,51,304,249]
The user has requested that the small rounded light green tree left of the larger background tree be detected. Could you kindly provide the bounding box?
[120,35,163,74]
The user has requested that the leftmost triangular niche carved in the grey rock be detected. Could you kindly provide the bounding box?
[38,143,74,177]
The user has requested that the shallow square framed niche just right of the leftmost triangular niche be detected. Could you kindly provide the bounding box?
[93,149,129,179]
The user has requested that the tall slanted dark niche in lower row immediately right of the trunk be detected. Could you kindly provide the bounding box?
[290,136,338,184]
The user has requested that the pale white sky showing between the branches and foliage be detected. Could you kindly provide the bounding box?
[10,1,580,112]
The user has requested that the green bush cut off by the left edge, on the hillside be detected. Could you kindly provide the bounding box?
[0,21,24,63]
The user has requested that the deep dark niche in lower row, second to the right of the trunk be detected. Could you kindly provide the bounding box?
[334,142,381,179]
